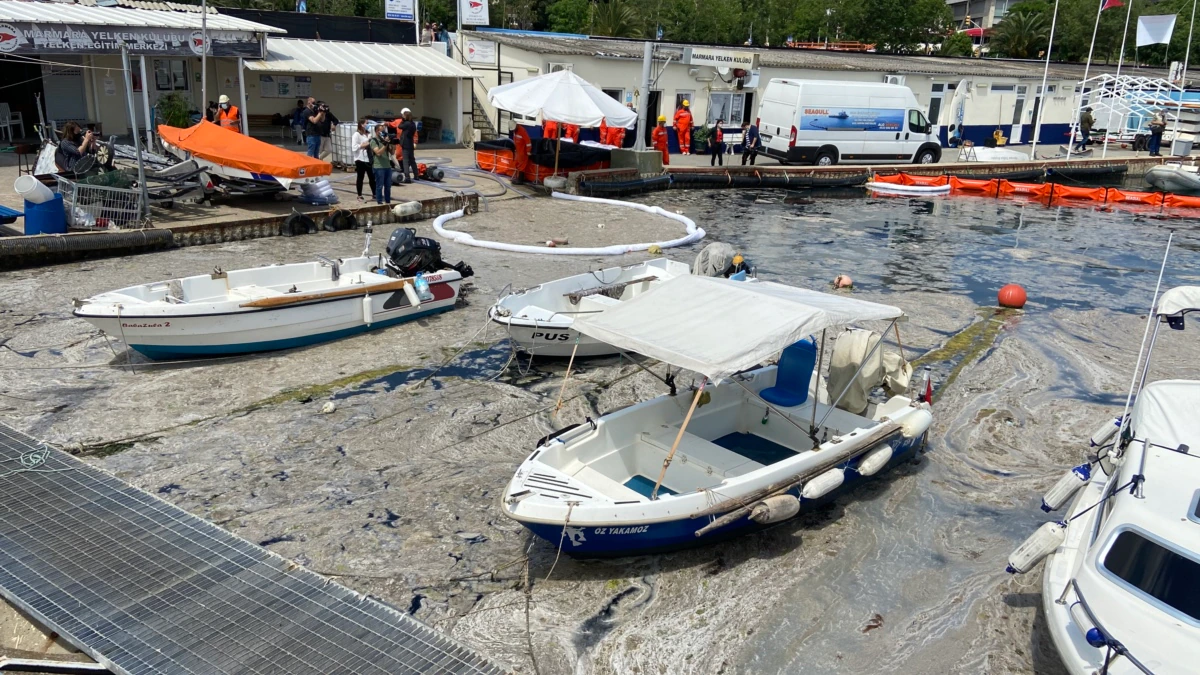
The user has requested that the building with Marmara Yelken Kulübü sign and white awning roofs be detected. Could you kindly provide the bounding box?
[0,0,473,143]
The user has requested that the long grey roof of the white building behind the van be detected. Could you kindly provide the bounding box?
[467,31,1166,80]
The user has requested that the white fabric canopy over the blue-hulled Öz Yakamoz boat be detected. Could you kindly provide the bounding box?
[574,275,904,382]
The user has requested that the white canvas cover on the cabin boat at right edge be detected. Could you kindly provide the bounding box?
[1129,380,1200,448]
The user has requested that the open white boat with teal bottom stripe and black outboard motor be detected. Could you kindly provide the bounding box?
[74,227,473,359]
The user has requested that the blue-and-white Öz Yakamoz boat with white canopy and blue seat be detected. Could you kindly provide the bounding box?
[502,275,932,557]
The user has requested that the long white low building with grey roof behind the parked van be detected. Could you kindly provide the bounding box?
[464,30,1165,151]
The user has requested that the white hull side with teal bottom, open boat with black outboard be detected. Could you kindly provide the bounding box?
[74,279,460,360]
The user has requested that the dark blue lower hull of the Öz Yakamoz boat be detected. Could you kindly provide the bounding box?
[512,431,928,558]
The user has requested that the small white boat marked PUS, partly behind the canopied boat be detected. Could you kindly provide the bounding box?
[487,258,691,357]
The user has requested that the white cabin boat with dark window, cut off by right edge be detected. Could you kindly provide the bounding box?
[1008,286,1200,675]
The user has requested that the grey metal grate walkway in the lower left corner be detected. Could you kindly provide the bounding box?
[0,424,503,675]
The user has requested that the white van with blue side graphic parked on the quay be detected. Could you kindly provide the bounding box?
[757,79,942,166]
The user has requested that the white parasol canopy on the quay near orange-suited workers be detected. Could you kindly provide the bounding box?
[487,71,637,129]
